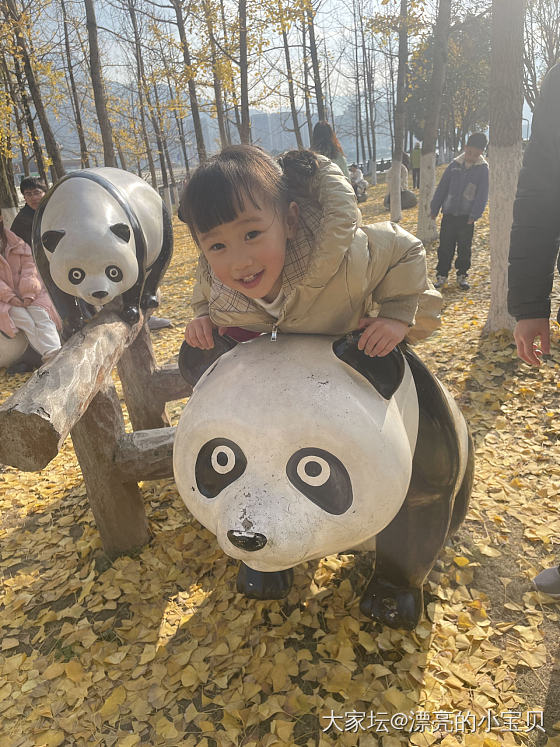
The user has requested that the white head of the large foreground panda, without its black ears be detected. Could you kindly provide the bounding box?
[173,335,418,571]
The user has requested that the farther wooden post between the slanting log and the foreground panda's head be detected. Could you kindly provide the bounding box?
[117,324,171,431]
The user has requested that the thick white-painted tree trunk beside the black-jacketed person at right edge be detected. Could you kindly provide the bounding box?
[483,0,525,334]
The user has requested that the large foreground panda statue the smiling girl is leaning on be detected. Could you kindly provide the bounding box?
[173,332,474,629]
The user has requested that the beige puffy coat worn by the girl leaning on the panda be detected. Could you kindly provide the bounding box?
[192,156,441,342]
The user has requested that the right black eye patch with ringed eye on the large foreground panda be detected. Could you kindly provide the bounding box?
[286,448,353,516]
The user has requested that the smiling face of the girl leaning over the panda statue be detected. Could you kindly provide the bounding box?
[197,200,298,301]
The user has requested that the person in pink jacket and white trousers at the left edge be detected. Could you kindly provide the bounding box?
[0,215,61,362]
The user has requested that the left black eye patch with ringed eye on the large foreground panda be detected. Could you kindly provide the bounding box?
[195,438,247,498]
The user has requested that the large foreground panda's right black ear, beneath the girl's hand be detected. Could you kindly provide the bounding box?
[333,329,404,399]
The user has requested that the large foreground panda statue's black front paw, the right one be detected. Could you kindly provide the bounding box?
[360,576,424,630]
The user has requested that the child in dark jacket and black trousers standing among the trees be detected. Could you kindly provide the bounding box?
[430,132,488,290]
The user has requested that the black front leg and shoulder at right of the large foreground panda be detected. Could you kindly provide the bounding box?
[360,351,473,630]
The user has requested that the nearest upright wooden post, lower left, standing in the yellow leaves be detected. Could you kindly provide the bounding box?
[71,379,150,557]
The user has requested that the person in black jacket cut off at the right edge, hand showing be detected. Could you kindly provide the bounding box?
[508,64,560,600]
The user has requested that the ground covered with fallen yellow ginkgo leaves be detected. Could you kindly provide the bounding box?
[0,177,560,747]
